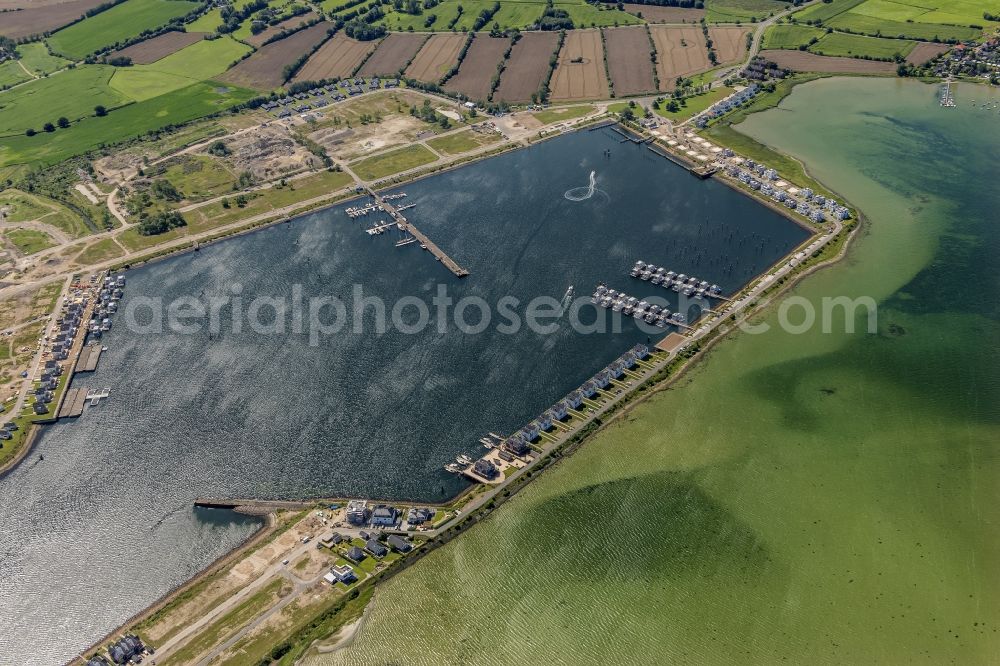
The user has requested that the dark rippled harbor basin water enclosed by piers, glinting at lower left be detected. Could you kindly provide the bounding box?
[0,124,807,663]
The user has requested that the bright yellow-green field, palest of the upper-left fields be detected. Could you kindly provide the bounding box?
[111,36,251,102]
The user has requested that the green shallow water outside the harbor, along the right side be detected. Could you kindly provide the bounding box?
[314,78,1000,665]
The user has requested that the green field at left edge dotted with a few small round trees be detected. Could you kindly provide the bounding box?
[0,65,129,137]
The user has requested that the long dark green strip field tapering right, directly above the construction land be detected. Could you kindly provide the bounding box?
[0,82,255,166]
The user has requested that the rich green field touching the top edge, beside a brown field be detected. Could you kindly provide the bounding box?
[48,0,198,60]
